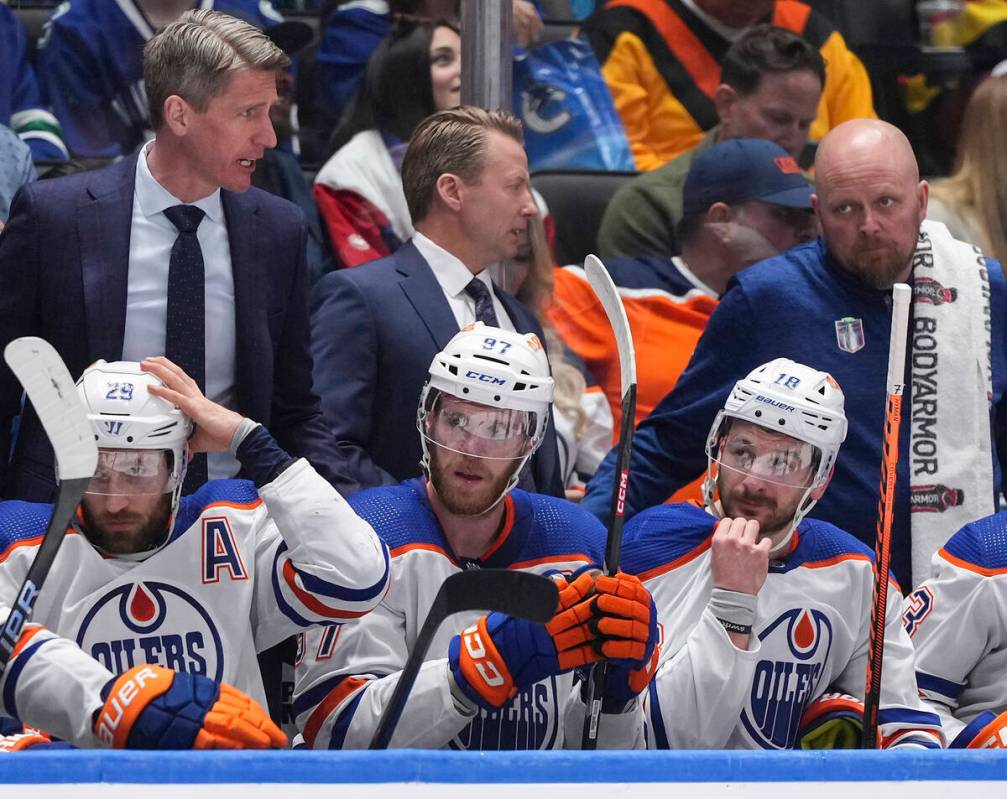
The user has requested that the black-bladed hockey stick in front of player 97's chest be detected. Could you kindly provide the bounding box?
[368,568,559,749]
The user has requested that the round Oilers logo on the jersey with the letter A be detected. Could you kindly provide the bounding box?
[77,580,224,681]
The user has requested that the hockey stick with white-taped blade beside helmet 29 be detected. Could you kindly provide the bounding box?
[0,337,98,677]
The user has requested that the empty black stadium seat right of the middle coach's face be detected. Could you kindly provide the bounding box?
[532,169,636,266]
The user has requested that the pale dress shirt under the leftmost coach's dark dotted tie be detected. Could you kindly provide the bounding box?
[123,144,240,480]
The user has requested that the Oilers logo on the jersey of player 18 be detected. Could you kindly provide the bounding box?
[741,608,833,749]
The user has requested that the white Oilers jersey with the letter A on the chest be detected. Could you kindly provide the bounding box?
[0,459,389,746]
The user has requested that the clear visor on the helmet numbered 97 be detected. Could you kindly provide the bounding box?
[421,394,535,460]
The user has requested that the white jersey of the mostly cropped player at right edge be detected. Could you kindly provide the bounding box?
[902,513,1007,741]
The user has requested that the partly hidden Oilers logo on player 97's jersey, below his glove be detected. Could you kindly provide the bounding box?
[449,677,560,750]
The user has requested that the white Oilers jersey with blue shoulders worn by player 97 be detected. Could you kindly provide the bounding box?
[294,480,605,750]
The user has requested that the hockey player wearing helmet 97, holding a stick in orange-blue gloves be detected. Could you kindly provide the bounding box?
[294,322,657,750]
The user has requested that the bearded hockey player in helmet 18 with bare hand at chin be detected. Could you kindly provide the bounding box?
[588,359,944,749]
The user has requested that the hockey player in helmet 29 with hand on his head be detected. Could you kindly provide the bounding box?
[0,358,389,749]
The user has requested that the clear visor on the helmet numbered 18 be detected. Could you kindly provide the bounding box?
[707,419,822,489]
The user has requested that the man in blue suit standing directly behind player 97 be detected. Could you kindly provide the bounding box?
[311,107,563,497]
